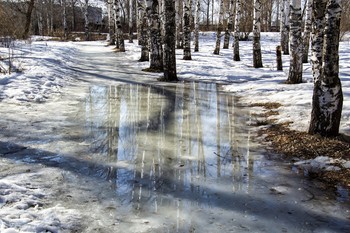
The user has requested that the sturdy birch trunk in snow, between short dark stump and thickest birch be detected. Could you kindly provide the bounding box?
[287,0,303,84]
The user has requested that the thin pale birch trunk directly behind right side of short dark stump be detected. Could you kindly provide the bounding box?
[281,0,290,55]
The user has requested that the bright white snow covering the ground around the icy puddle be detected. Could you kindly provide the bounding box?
[0,33,350,233]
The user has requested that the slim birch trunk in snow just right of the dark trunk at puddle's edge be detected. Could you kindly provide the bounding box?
[183,0,192,60]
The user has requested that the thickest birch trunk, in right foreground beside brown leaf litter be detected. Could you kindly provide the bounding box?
[309,0,343,137]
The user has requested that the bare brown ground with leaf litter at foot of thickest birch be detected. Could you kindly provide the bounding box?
[252,103,350,188]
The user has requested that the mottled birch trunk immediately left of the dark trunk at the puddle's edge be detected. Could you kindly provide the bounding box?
[146,0,163,71]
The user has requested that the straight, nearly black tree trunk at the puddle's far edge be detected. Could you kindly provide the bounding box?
[164,0,177,82]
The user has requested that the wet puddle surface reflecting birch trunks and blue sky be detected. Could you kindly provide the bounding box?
[84,83,258,226]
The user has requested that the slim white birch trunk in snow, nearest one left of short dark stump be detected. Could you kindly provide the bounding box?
[253,0,263,68]
